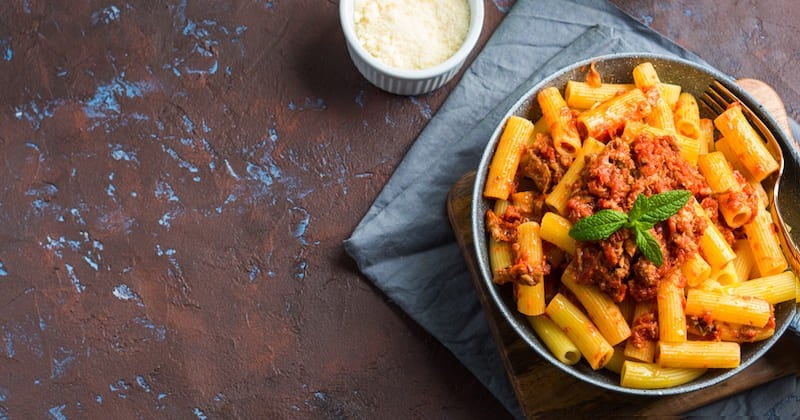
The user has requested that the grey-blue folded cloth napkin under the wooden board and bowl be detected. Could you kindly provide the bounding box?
[344,0,796,417]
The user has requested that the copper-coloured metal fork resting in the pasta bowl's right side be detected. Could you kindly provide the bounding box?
[700,80,800,274]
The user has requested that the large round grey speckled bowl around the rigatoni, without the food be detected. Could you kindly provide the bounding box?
[471,53,796,396]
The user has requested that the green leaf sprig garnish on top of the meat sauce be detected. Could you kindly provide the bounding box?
[569,190,692,267]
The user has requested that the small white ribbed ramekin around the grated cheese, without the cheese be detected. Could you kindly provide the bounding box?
[339,0,483,96]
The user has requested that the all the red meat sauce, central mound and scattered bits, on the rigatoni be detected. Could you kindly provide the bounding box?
[486,128,758,347]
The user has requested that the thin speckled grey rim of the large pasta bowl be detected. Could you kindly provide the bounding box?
[470,52,796,396]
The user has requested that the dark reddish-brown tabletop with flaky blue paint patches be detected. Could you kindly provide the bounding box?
[0,0,800,418]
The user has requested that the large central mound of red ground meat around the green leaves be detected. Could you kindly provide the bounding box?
[567,131,716,302]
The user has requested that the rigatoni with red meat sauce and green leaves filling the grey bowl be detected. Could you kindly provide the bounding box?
[485,59,800,389]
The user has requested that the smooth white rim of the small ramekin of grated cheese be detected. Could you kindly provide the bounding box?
[339,0,484,80]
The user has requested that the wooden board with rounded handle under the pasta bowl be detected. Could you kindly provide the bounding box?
[447,79,800,418]
